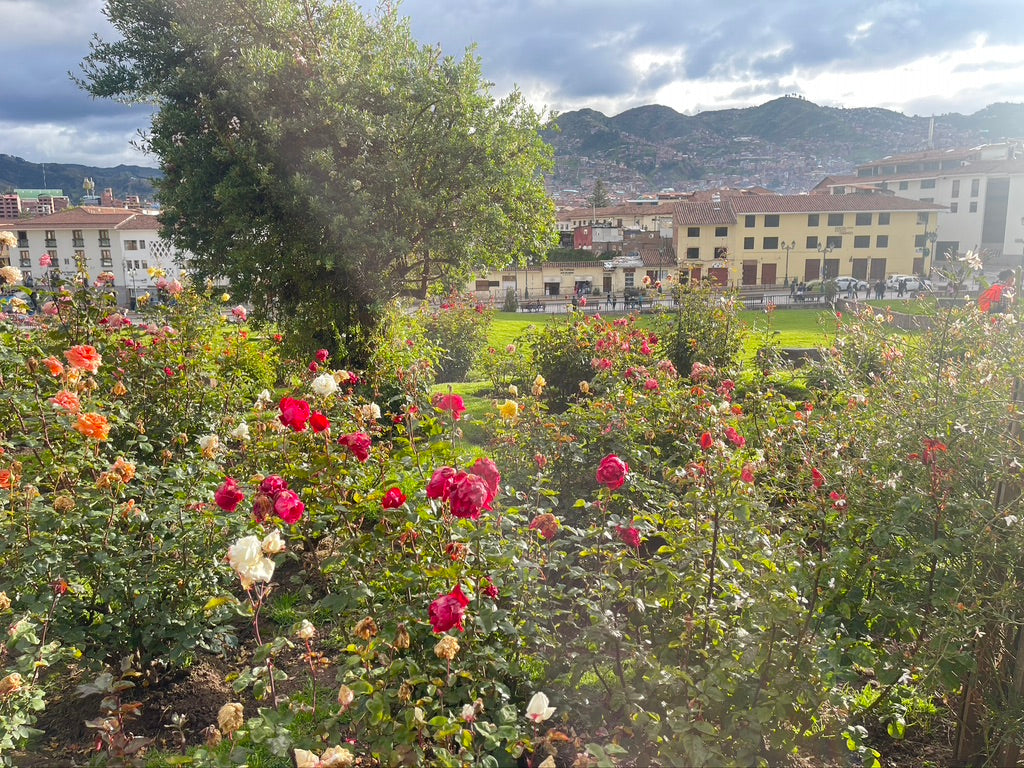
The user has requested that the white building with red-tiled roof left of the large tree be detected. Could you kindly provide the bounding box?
[0,206,187,305]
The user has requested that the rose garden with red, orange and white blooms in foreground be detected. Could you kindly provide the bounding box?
[0,266,1024,768]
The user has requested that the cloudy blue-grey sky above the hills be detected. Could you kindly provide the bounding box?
[0,0,1024,166]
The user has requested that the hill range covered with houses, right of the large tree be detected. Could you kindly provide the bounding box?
[544,96,1024,203]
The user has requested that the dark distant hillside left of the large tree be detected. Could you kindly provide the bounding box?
[0,155,161,203]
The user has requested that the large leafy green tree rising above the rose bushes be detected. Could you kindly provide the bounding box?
[81,0,554,358]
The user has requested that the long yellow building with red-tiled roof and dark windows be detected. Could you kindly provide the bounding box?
[674,193,944,286]
